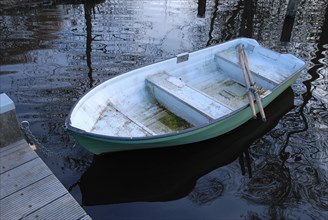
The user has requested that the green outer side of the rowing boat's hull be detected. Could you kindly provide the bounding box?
[73,72,300,154]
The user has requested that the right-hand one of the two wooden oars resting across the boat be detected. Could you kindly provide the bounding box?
[238,45,266,121]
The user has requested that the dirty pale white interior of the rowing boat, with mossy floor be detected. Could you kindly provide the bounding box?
[71,39,299,137]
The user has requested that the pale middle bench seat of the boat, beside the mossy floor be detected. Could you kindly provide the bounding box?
[147,72,232,126]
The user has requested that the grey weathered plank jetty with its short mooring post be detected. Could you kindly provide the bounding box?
[0,94,91,220]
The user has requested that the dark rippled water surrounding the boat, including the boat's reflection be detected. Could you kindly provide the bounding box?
[0,0,328,219]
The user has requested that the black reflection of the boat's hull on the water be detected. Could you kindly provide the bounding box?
[79,88,294,206]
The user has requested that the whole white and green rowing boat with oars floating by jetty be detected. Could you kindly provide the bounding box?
[65,38,305,154]
